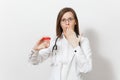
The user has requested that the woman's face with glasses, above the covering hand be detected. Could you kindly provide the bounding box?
[60,12,76,32]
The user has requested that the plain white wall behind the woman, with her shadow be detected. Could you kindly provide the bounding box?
[0,0,120,80]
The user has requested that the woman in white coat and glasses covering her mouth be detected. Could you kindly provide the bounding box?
[30,7,92,80]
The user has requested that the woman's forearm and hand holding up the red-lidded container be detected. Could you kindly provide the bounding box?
[29,36,53,65]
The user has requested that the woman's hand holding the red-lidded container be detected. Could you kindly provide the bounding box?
[33,38,50,51]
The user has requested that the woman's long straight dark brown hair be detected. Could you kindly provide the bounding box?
[56,7,79,37]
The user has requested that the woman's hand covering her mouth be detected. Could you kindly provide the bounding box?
[64,27,80,48]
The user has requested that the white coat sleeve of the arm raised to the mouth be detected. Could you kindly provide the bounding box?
[74,37,92,73]
